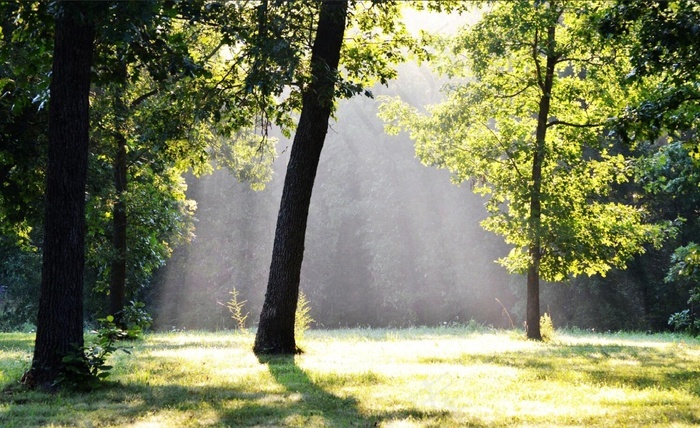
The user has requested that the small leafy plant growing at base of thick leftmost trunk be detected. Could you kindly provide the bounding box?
[54,315,130,391]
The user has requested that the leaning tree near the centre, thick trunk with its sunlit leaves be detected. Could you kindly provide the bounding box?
[252,1,415,354]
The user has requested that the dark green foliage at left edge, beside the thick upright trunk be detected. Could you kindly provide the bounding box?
[0,2,53,329]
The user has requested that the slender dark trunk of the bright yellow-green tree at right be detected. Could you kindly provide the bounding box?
[526,21,557,340]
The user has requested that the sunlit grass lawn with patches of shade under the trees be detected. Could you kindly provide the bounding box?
[0,328,700,427]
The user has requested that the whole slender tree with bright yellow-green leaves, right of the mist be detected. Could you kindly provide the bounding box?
[381,1,658,339]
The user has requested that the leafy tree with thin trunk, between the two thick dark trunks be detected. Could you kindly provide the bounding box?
[85,2,275,327]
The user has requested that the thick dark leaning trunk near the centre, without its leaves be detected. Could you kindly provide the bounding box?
[254,0,347,354]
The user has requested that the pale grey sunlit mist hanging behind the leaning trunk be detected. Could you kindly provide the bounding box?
[152,53,515,329]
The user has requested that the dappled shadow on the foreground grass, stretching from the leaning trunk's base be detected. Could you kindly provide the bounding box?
[0,356,452,428]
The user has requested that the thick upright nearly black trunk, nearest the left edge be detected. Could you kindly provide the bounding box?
[25,2,95,387]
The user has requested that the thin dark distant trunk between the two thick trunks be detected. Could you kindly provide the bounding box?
[109,133,127,328]
